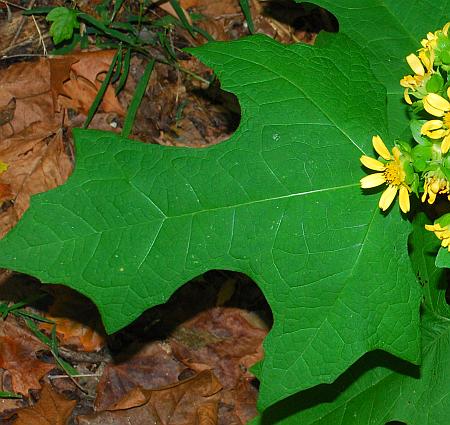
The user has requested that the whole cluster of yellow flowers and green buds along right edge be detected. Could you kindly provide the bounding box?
[360,22,450,251]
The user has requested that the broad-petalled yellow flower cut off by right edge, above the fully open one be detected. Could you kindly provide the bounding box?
[420,87,450,154]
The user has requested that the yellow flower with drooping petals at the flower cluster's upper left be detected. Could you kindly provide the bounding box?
[400,49,434,105]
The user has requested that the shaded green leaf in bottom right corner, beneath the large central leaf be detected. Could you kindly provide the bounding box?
[254,215,450,425]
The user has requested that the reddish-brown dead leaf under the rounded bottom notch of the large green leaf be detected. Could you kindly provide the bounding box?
[170,307,268,423]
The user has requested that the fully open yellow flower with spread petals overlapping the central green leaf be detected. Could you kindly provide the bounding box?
[360,136,411,213]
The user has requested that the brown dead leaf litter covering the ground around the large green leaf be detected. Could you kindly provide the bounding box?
[0,0,330,425]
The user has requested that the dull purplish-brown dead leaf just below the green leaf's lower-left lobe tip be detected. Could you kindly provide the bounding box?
[95,342,185,410]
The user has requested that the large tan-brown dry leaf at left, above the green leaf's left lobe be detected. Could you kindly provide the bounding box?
[0,51,124,237]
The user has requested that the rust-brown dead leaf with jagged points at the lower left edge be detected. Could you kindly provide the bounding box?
[0,316,55,395]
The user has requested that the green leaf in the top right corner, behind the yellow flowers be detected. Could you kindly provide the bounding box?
[314,0,450,138]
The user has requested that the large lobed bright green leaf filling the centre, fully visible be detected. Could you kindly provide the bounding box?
[0,36,420,409]
